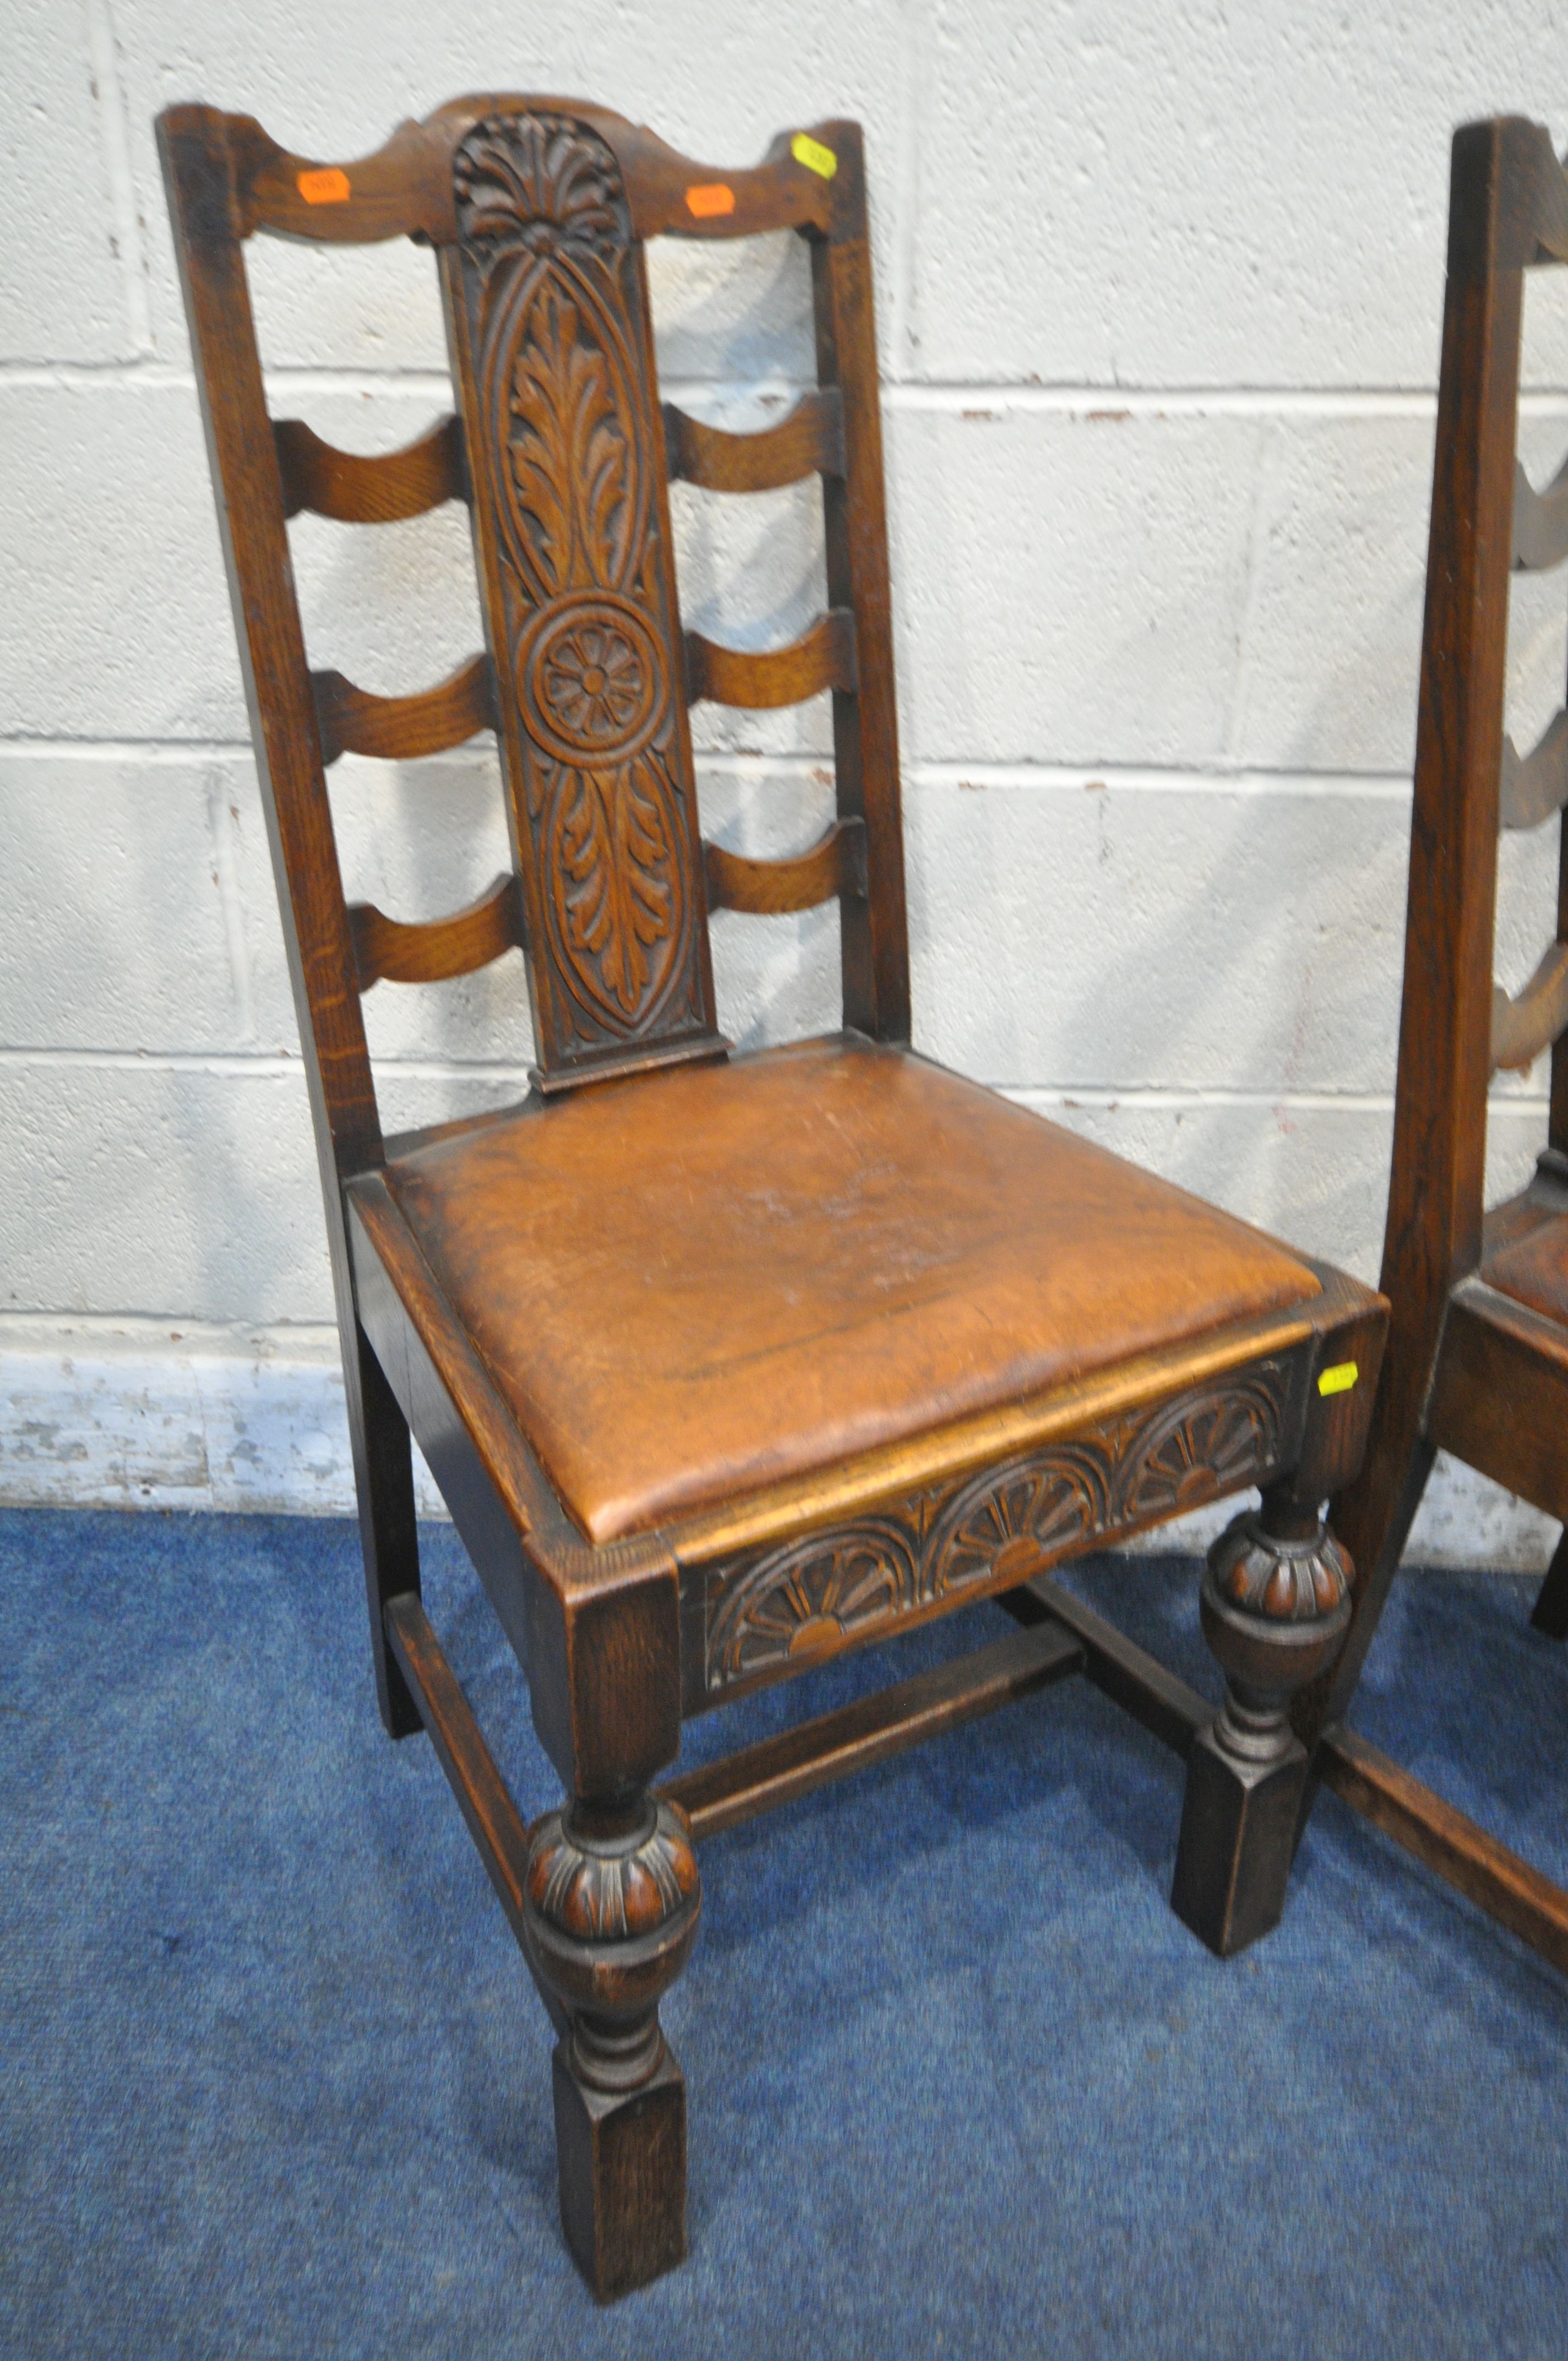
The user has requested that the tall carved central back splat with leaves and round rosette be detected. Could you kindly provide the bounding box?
[454,113,711,1065]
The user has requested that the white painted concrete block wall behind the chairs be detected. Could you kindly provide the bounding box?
[0,0,1568,1563]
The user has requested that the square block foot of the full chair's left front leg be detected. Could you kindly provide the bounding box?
[553,2042,687,2304]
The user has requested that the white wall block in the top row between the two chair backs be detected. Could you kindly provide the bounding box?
[909,0,1568,387]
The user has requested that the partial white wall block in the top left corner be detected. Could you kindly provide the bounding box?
[0,7,137,361]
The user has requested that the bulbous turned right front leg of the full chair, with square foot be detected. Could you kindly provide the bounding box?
[1171,1492,1353,1960]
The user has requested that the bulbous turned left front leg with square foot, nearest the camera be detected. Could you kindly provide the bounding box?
[524,1794,701,2302]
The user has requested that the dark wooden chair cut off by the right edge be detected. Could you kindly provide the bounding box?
[1297,116,1568,1967]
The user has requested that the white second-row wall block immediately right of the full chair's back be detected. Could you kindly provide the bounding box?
[888,396,1261,765]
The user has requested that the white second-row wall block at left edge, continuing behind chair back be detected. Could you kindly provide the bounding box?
[0,385,831,751]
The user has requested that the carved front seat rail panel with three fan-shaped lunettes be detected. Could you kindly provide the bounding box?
[704,1358,1297,1695]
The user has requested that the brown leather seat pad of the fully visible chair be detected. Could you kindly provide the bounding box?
[387,1036,1317,1542]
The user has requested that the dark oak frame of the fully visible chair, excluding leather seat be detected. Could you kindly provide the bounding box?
[158,97,1386,2297]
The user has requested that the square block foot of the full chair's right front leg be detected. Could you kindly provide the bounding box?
[1171,1728,1306,1960]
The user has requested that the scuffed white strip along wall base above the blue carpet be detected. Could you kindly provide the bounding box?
[0,1318,1559,1573]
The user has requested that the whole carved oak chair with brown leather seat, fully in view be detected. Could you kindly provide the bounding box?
[161,97,1386,2297]
